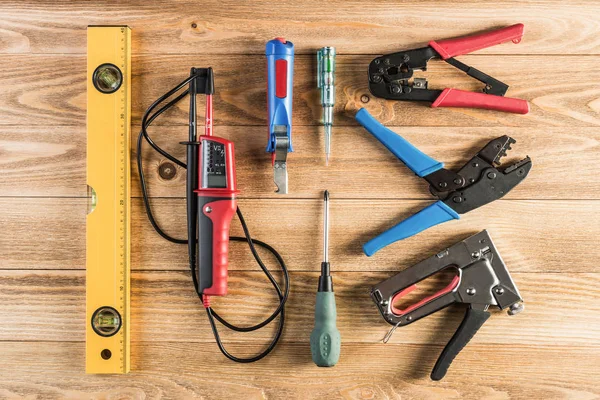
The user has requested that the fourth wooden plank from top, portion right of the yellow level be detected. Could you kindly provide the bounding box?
[132,199,600,272]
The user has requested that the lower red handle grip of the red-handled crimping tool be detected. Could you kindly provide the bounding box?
[431,89,529,114]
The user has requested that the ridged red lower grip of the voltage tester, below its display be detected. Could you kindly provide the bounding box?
[202,199,237,296]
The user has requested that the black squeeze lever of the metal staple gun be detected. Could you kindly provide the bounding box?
[431,307,490,381]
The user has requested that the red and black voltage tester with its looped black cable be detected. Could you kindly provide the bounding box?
[137,68,289,363]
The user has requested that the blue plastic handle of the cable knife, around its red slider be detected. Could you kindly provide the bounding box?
[265,39,294,153]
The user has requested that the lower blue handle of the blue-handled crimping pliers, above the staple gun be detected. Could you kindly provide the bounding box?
[363,200,460,257]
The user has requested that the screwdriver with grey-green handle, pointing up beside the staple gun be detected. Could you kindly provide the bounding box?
[310,190,342,367]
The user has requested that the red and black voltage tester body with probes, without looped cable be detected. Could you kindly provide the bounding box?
[184,68,238,307]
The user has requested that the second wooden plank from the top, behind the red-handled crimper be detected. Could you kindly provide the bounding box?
[0,55,600,126]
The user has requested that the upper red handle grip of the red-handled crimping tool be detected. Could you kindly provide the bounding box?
[429,24,525,60]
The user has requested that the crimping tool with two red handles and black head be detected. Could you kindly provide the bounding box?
[369,24,529,114]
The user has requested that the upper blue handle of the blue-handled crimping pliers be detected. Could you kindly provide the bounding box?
[355,108,444,178]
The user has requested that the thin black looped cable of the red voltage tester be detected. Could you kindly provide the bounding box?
[137,77,290,363]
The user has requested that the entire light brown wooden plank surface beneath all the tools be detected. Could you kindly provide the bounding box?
[0,0,600,399]
